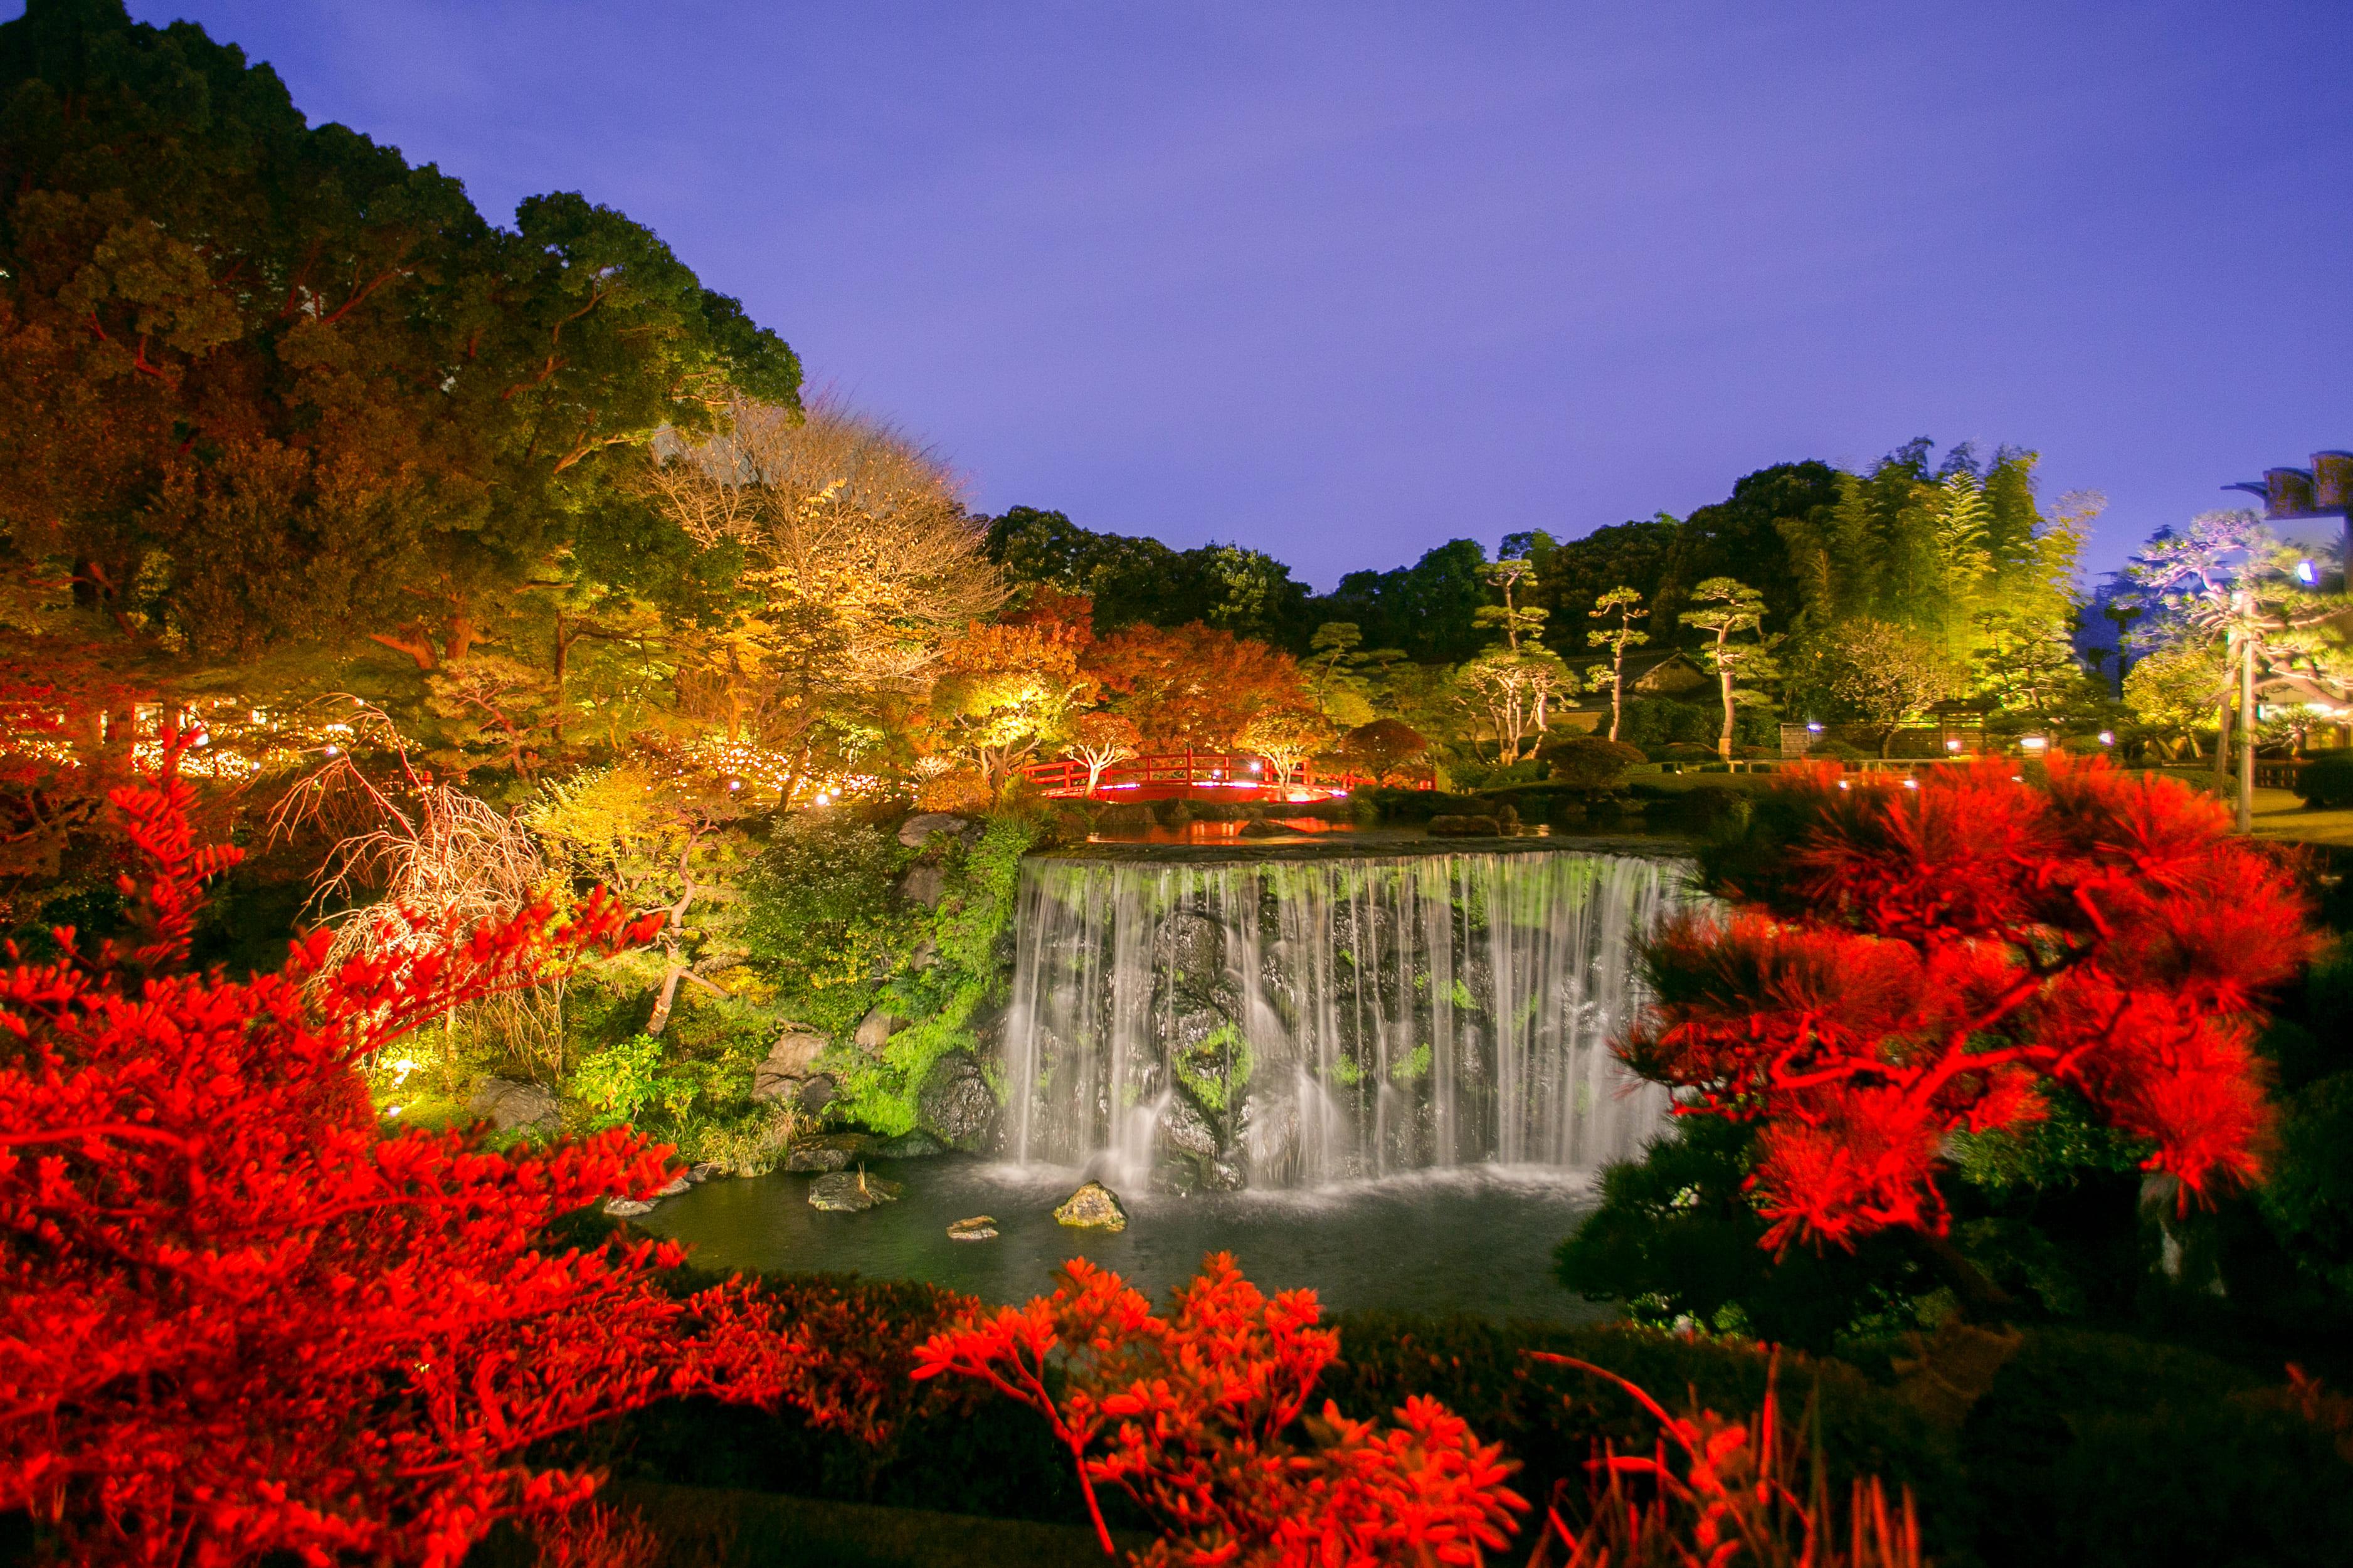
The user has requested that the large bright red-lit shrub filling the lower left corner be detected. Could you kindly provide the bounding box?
[0,766,859,1564]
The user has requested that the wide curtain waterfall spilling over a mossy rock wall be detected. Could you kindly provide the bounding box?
[1005,849,1689,1187]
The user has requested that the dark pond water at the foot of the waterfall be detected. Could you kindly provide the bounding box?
[640,1157,1609,1321]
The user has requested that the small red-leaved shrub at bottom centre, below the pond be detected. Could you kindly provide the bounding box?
[916,1253,1527,1568]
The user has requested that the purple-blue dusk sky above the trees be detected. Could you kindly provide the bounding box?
[83,0,2353,587]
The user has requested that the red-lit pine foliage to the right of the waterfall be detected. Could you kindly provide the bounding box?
[1624,759,2313,1246]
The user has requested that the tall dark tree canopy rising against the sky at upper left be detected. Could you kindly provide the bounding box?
[0,0,800,668]
